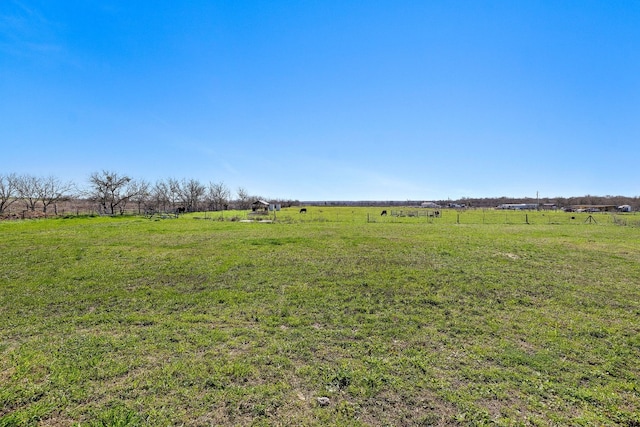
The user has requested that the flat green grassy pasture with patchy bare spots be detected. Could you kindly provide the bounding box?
[0,207,640,426]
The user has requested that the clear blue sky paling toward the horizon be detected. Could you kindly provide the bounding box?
[0,0,640,200]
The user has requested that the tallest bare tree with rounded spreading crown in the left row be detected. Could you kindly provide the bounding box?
[89,171,138,215]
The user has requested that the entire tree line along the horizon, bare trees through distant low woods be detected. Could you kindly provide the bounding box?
[0,170,640,215]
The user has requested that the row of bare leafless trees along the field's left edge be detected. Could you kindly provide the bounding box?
[0,170,297,215]
